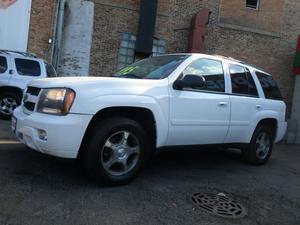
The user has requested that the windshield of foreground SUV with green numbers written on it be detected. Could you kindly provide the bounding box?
[112,55,189,80]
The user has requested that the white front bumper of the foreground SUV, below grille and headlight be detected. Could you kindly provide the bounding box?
[13,106,92,158]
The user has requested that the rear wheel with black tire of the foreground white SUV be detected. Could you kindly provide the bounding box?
[242,125,274,165]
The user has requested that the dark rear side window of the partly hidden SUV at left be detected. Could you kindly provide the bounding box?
[15,59,41,77]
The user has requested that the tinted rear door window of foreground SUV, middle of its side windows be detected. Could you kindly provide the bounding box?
[229,64,258,97]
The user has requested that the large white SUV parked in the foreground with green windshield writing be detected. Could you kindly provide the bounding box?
[12,54,286,184]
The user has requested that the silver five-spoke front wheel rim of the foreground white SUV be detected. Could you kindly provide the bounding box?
[101,131,140,176]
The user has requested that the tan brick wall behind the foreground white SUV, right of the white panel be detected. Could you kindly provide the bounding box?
[85,0,300,111]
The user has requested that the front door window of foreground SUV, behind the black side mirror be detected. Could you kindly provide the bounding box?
[183,59,225,92]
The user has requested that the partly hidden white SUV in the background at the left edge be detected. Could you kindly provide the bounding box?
[0,49,56,119]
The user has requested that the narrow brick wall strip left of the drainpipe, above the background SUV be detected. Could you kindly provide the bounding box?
[28,0,57,61]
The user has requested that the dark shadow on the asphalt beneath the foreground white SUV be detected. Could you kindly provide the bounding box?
[0,145,241,189]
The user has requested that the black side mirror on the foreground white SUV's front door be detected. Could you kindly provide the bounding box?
[173,74,205,90]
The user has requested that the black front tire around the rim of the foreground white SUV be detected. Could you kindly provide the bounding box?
[83,117,150,185]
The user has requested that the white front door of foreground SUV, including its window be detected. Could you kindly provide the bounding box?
[168,58,230,145]
